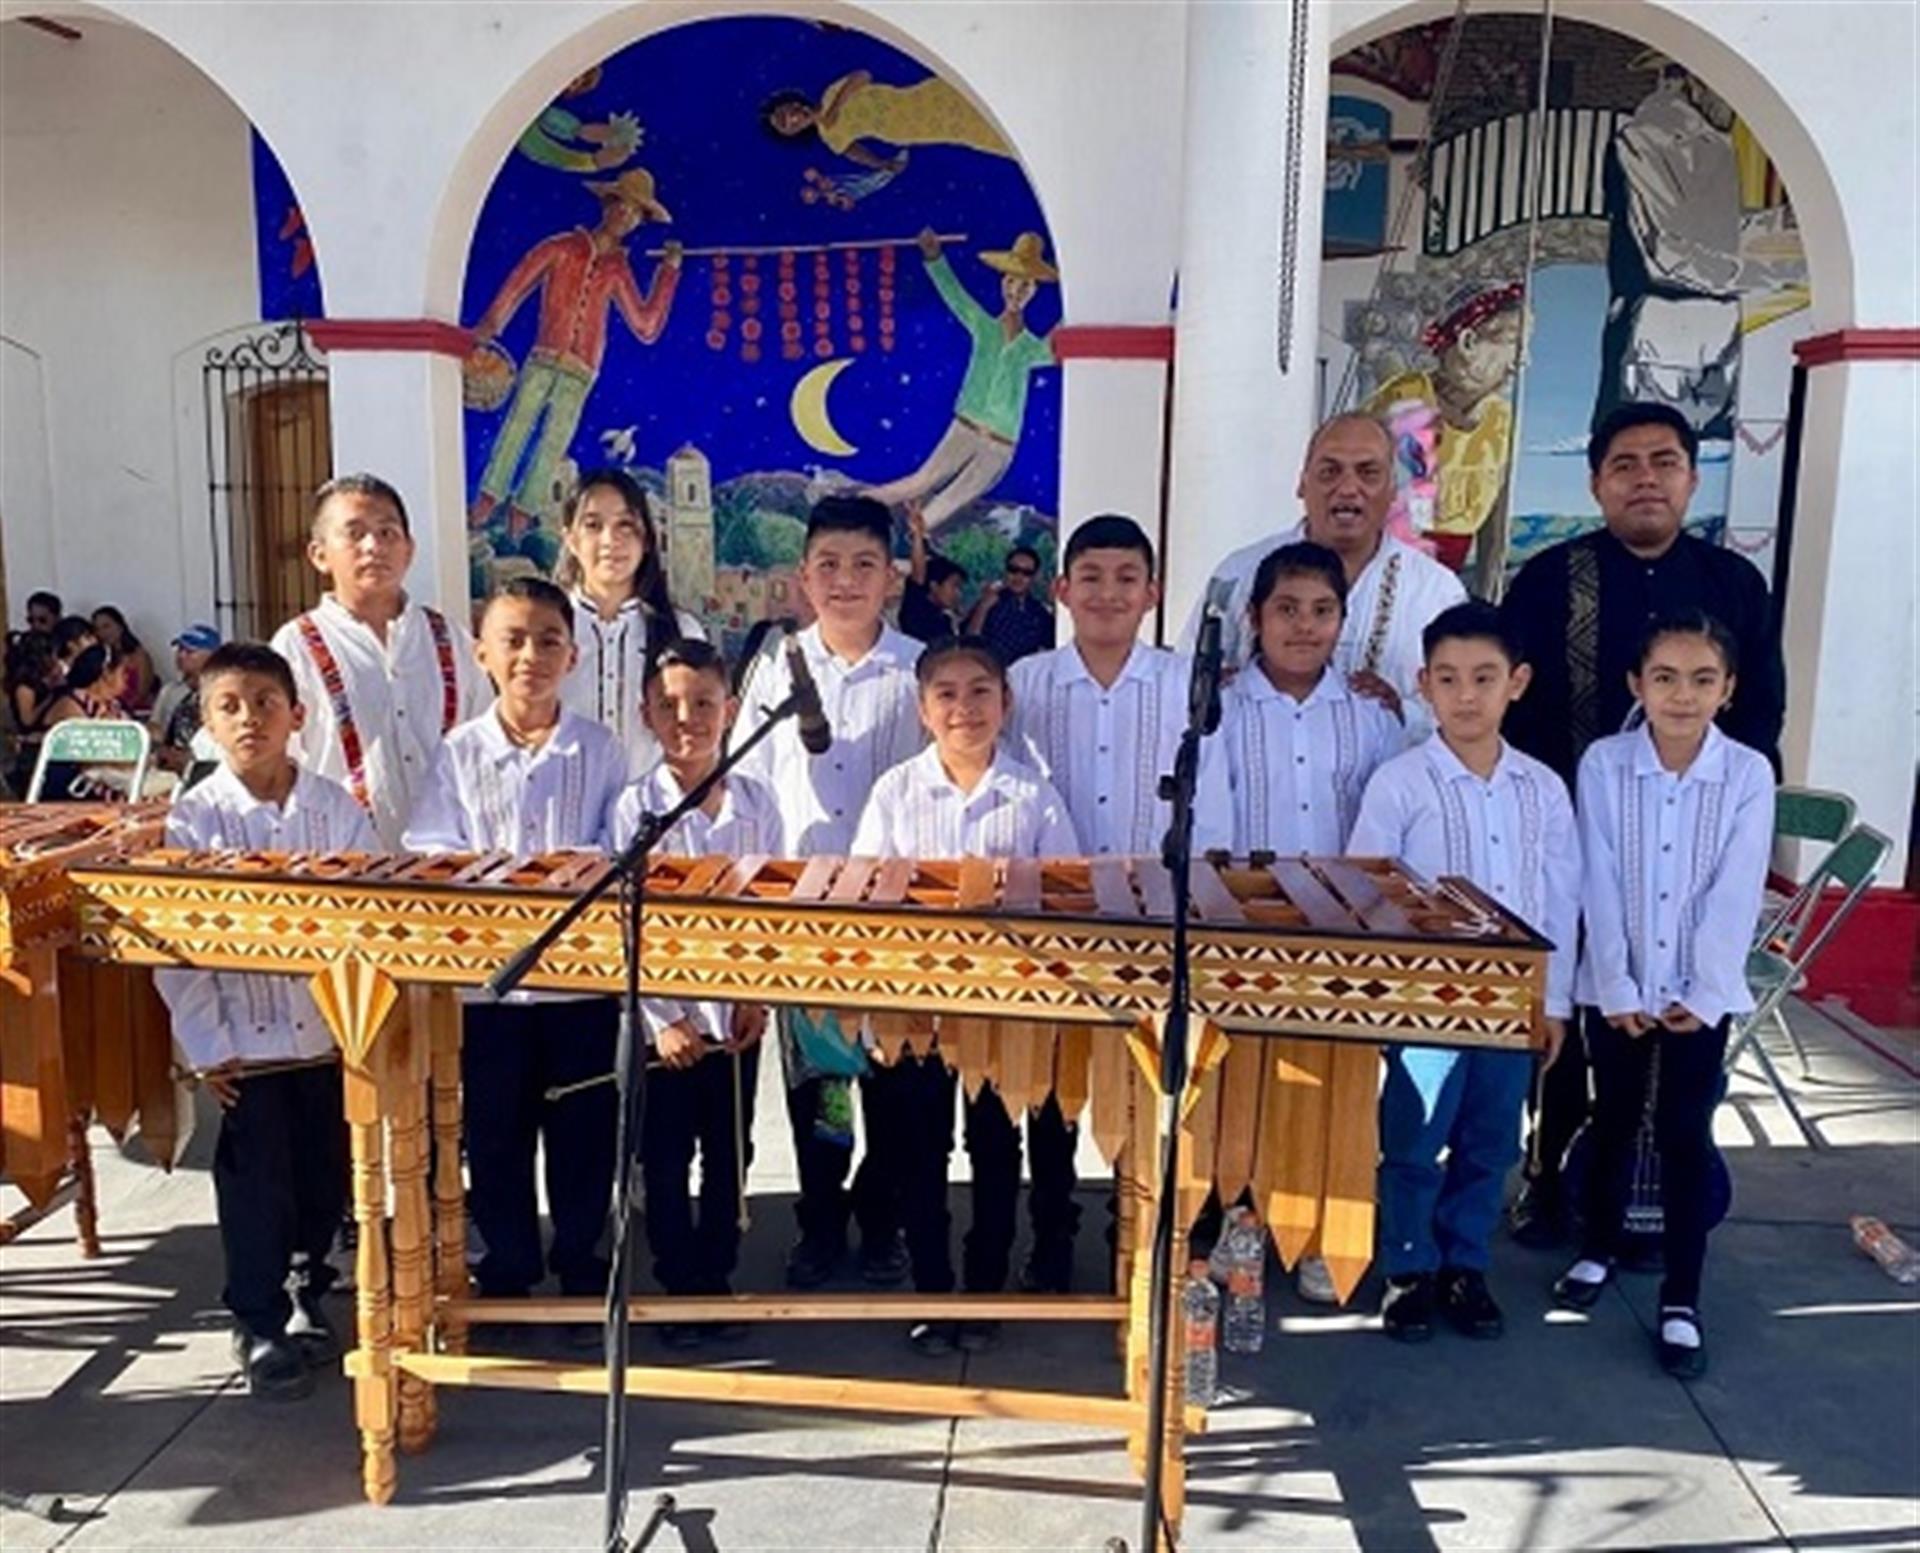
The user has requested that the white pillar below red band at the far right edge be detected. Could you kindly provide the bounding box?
[1782,359,1920,885]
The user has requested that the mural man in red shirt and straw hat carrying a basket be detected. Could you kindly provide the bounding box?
[467,167,680,564]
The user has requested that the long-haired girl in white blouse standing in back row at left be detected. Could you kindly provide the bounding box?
[553,468,707,777]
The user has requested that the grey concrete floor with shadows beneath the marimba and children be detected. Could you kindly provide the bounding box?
[0,1008,1920,1553]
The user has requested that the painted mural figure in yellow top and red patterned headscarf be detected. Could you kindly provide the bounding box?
[1367,280,1526,572]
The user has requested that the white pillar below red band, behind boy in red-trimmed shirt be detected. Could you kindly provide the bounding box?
[326,349,467,620]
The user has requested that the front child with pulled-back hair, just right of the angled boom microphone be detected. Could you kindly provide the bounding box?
[852,637,1079,1355]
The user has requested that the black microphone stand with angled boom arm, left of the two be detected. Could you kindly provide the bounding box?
[484,693,801,1553]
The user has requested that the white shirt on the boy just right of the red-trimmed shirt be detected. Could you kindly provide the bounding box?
[405,708,626,856]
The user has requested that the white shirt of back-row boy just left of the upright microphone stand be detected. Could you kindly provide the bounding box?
[1008,643,1231,854]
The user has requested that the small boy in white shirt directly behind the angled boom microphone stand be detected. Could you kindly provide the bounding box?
[611,641,781,1348]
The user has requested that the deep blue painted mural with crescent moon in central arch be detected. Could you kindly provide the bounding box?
[461,15,1060,649]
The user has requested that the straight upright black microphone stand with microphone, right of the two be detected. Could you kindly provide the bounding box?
[1140,607,1223,1553]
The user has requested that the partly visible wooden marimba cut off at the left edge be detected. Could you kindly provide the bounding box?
[0,804,175,1257]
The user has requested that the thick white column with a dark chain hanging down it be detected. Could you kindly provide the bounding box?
[1167,0,1327,637]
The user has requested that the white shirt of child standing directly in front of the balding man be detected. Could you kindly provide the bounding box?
[1219,664,1405,858]
